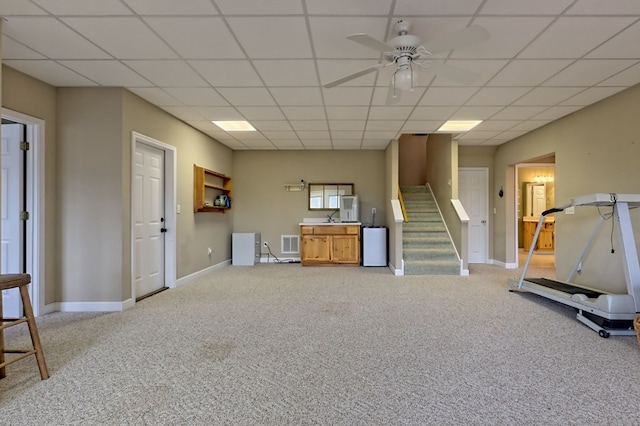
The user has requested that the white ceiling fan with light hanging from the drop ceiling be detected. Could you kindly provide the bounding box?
[324,19,490,104]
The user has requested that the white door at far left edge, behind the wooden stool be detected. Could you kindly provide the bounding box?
[0,124,25,318]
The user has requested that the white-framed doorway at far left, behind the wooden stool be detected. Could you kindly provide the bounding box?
[2,108,45,316]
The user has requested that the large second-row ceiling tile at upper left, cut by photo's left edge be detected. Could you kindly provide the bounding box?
[2,17,110,59]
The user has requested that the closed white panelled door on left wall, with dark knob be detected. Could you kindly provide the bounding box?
[133,143,166,298]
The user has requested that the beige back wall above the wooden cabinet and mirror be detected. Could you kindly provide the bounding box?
[231,150,388,257]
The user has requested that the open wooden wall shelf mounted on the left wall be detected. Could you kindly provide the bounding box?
[193,164,231,213]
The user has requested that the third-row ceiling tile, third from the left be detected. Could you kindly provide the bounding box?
[124,60,207,87]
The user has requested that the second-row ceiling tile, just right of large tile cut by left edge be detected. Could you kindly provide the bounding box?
[63,17,176,59]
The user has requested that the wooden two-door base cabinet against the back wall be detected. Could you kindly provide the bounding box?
[300,224,360,265]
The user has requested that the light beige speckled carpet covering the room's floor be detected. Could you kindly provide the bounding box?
[0,264,640,425]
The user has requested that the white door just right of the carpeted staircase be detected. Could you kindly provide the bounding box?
[458,168,489,263]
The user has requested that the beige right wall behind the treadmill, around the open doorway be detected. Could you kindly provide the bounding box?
[498,86,640,291]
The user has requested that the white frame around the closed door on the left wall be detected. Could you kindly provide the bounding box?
[130,132,177,305]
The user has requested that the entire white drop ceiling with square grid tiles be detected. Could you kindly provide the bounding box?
[0,0,640,150]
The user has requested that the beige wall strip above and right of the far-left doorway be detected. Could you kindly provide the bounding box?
[1,66,60,304]
